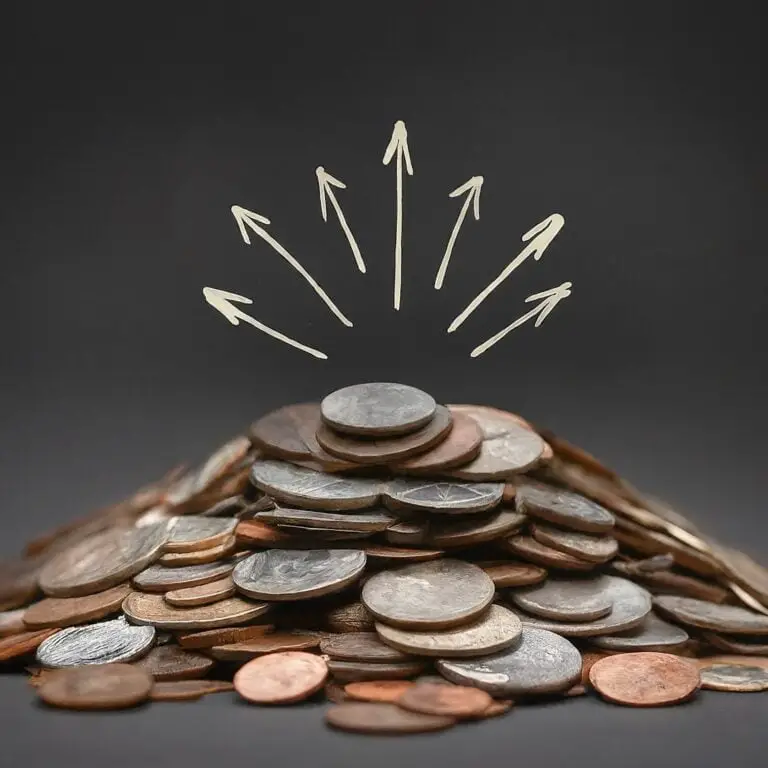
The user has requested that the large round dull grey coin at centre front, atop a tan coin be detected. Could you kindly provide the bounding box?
[361,559,495,629]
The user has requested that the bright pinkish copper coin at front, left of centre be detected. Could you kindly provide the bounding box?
[233,651,328,704]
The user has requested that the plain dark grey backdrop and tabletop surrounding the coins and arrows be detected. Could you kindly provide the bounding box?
[0,2,768,768]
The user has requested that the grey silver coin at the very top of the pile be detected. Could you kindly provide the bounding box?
[320,382,437,436]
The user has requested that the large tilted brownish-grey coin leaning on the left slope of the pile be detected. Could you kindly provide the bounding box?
[40,523,168,597]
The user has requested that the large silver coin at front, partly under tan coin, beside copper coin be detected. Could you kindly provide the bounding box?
[437,627,581,696]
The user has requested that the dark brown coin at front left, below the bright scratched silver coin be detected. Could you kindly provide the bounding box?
[37,664,153,710]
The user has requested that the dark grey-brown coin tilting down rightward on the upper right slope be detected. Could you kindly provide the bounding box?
[515,484,615,533]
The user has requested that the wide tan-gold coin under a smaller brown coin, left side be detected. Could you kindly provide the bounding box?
[123,592,269,630]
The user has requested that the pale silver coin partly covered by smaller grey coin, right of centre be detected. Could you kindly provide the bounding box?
[518,576,651,637]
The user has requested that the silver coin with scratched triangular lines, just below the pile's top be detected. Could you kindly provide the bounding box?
[383,477,504,514]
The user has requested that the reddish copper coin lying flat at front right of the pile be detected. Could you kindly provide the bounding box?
[589,652,701,707]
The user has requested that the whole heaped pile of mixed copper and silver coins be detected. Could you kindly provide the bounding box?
[0,383,768,733]
